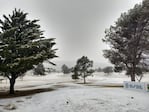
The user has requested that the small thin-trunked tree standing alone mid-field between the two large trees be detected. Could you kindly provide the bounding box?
[74,56,93,84]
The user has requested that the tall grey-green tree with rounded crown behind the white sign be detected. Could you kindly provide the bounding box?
[103,0,149,81]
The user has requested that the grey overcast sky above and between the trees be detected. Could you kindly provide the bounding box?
[0,0,142,66]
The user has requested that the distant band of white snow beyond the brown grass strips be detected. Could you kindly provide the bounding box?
[0,72,149,91]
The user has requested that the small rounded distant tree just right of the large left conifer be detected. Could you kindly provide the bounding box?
[33,63,45,75]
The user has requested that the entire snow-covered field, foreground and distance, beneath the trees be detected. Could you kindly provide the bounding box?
[0,73,149,112]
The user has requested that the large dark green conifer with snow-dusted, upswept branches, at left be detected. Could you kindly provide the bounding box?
[0,9,57,94]
